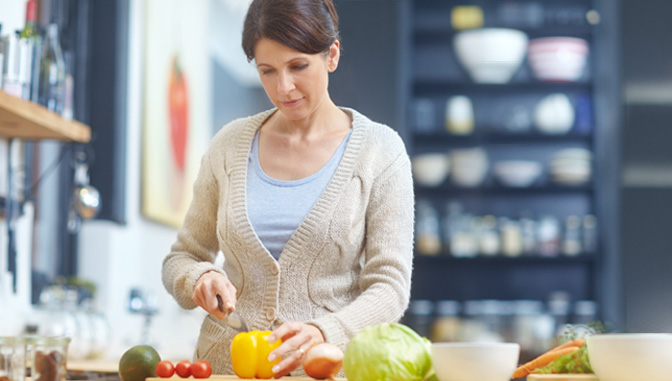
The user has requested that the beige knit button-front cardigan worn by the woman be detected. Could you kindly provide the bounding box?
[163,108,414,374]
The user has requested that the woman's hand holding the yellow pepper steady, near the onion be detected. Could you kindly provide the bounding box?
[268,321,325,378]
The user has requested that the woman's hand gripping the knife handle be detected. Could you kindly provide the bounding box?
[191,271,237,320]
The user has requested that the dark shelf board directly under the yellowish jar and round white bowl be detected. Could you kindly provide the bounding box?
[413,126,593,147]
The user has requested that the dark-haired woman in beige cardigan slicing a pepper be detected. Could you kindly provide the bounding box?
[163,0,414,377]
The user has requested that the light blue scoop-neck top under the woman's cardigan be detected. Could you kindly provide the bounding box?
[247,129,352,259]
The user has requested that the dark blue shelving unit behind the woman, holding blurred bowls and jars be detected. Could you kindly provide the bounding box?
[406,0,603,304]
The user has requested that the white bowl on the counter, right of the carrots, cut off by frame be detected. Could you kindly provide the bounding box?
[587,333,672,381]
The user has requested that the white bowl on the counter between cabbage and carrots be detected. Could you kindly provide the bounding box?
[432,342,520,381]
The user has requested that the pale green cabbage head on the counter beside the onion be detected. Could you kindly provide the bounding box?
[343,323,436,381]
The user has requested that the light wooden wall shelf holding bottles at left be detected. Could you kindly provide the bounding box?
[0,90,91,143]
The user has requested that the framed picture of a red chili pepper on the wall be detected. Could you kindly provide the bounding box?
[141,0,212,227]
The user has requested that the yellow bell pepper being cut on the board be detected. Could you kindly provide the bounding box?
[231,331,282,379]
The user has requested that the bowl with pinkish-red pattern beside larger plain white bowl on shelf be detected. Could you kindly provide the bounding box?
[527,37,590,82]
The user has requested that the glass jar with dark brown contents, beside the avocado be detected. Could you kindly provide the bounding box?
[26,336,70,381]
